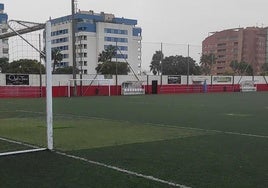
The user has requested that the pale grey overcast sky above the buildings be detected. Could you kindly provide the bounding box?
[1,0,268,69]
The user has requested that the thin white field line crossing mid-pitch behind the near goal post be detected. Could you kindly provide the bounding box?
[14,110,268,139]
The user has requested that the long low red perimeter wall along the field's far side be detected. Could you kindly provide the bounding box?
[0,84,268,98]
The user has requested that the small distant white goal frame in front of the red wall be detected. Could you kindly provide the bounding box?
[68,79,111,97]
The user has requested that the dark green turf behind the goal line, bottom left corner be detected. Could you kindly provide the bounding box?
[0,151,172,188]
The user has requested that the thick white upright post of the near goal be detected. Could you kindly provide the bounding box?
[46,21,53,150]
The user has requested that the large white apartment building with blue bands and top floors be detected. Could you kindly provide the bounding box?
[51,11,142,74]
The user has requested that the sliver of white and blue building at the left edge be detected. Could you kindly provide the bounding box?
[0,3,9,58]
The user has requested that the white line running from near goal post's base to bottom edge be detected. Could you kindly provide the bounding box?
[54,151,191,188]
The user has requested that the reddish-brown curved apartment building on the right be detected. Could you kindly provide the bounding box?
[202,27,268,75]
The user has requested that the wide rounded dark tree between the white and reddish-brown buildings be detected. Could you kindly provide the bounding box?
[162,55,201,75]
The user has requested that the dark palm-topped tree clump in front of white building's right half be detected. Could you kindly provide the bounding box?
[96,45,130,75]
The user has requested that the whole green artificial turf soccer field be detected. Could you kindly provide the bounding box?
[0,92,268,188]
